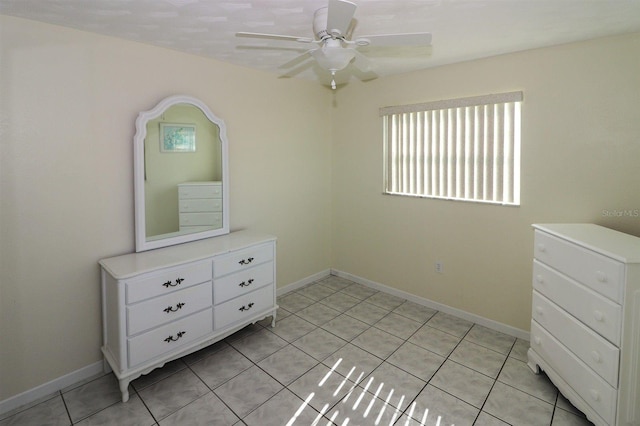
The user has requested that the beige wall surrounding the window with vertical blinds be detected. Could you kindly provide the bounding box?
[332,34,640,330]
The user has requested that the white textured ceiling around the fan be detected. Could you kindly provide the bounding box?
[0,0,640,84]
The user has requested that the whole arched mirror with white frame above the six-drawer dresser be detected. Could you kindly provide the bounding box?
[134,96,229,252]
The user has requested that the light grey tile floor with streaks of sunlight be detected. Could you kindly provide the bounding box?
[0,276,591,426]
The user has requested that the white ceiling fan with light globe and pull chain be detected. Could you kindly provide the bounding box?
[236,0,431,90]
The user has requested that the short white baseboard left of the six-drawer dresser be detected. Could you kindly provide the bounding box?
[0,361,104,418]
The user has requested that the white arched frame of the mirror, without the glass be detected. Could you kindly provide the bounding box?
[133,95,229,252]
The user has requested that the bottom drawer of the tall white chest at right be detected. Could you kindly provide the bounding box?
[531,321,617,424]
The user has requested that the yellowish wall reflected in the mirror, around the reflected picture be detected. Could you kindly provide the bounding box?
[144,104,222,238]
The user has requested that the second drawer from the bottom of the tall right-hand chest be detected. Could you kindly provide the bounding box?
[532,291,620,388]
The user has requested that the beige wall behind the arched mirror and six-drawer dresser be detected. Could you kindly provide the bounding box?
[0,16,331,401]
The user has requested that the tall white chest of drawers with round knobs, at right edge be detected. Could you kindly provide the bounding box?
[528,224,640,426]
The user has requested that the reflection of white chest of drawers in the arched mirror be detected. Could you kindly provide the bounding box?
[178,182,222,232]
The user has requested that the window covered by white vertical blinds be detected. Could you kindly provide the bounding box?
[380,92,523,205]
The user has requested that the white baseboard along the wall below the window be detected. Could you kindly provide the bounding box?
[331,269,529,341]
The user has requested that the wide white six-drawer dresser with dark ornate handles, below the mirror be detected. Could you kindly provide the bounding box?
[100,231,278,401]
